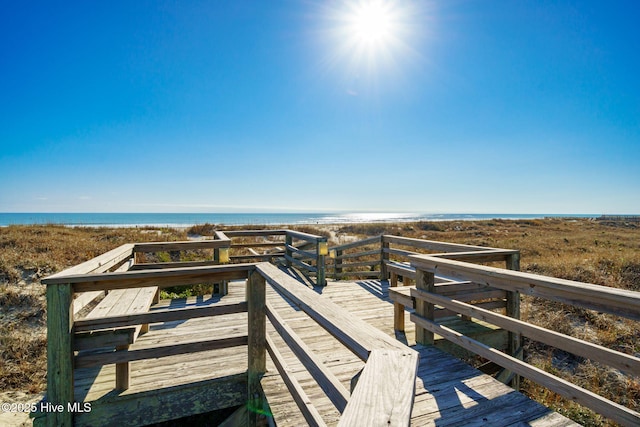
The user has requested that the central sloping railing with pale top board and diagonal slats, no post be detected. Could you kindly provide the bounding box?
[257,263,419,426]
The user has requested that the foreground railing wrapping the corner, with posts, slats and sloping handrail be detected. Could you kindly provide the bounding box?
[43,244,418,426]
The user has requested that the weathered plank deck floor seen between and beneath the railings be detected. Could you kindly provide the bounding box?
[74,280,574,426]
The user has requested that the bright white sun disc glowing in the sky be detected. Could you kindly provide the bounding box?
[351,1,393,44]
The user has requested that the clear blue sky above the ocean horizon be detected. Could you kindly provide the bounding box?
[0,0,640,214]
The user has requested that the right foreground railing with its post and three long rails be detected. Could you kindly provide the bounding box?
[410,255,640,426]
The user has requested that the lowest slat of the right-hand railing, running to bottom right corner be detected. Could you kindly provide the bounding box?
[411,313,640,426]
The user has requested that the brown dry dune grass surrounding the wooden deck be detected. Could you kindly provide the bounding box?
[0,219,640,425]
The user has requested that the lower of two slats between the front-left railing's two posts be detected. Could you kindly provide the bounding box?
[73,335,248,368]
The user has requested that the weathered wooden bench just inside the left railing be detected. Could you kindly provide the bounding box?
[74,286,158,390]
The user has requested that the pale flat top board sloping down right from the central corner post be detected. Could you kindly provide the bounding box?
[256,263,407,360]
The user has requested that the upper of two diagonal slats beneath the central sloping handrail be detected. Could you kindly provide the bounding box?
[267,303,349,412]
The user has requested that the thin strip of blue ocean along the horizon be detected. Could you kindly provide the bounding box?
[0,212,598,227]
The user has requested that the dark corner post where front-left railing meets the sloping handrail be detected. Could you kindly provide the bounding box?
[247,270,267,426]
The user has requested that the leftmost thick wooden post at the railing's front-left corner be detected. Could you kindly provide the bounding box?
[46,284,74,427]
